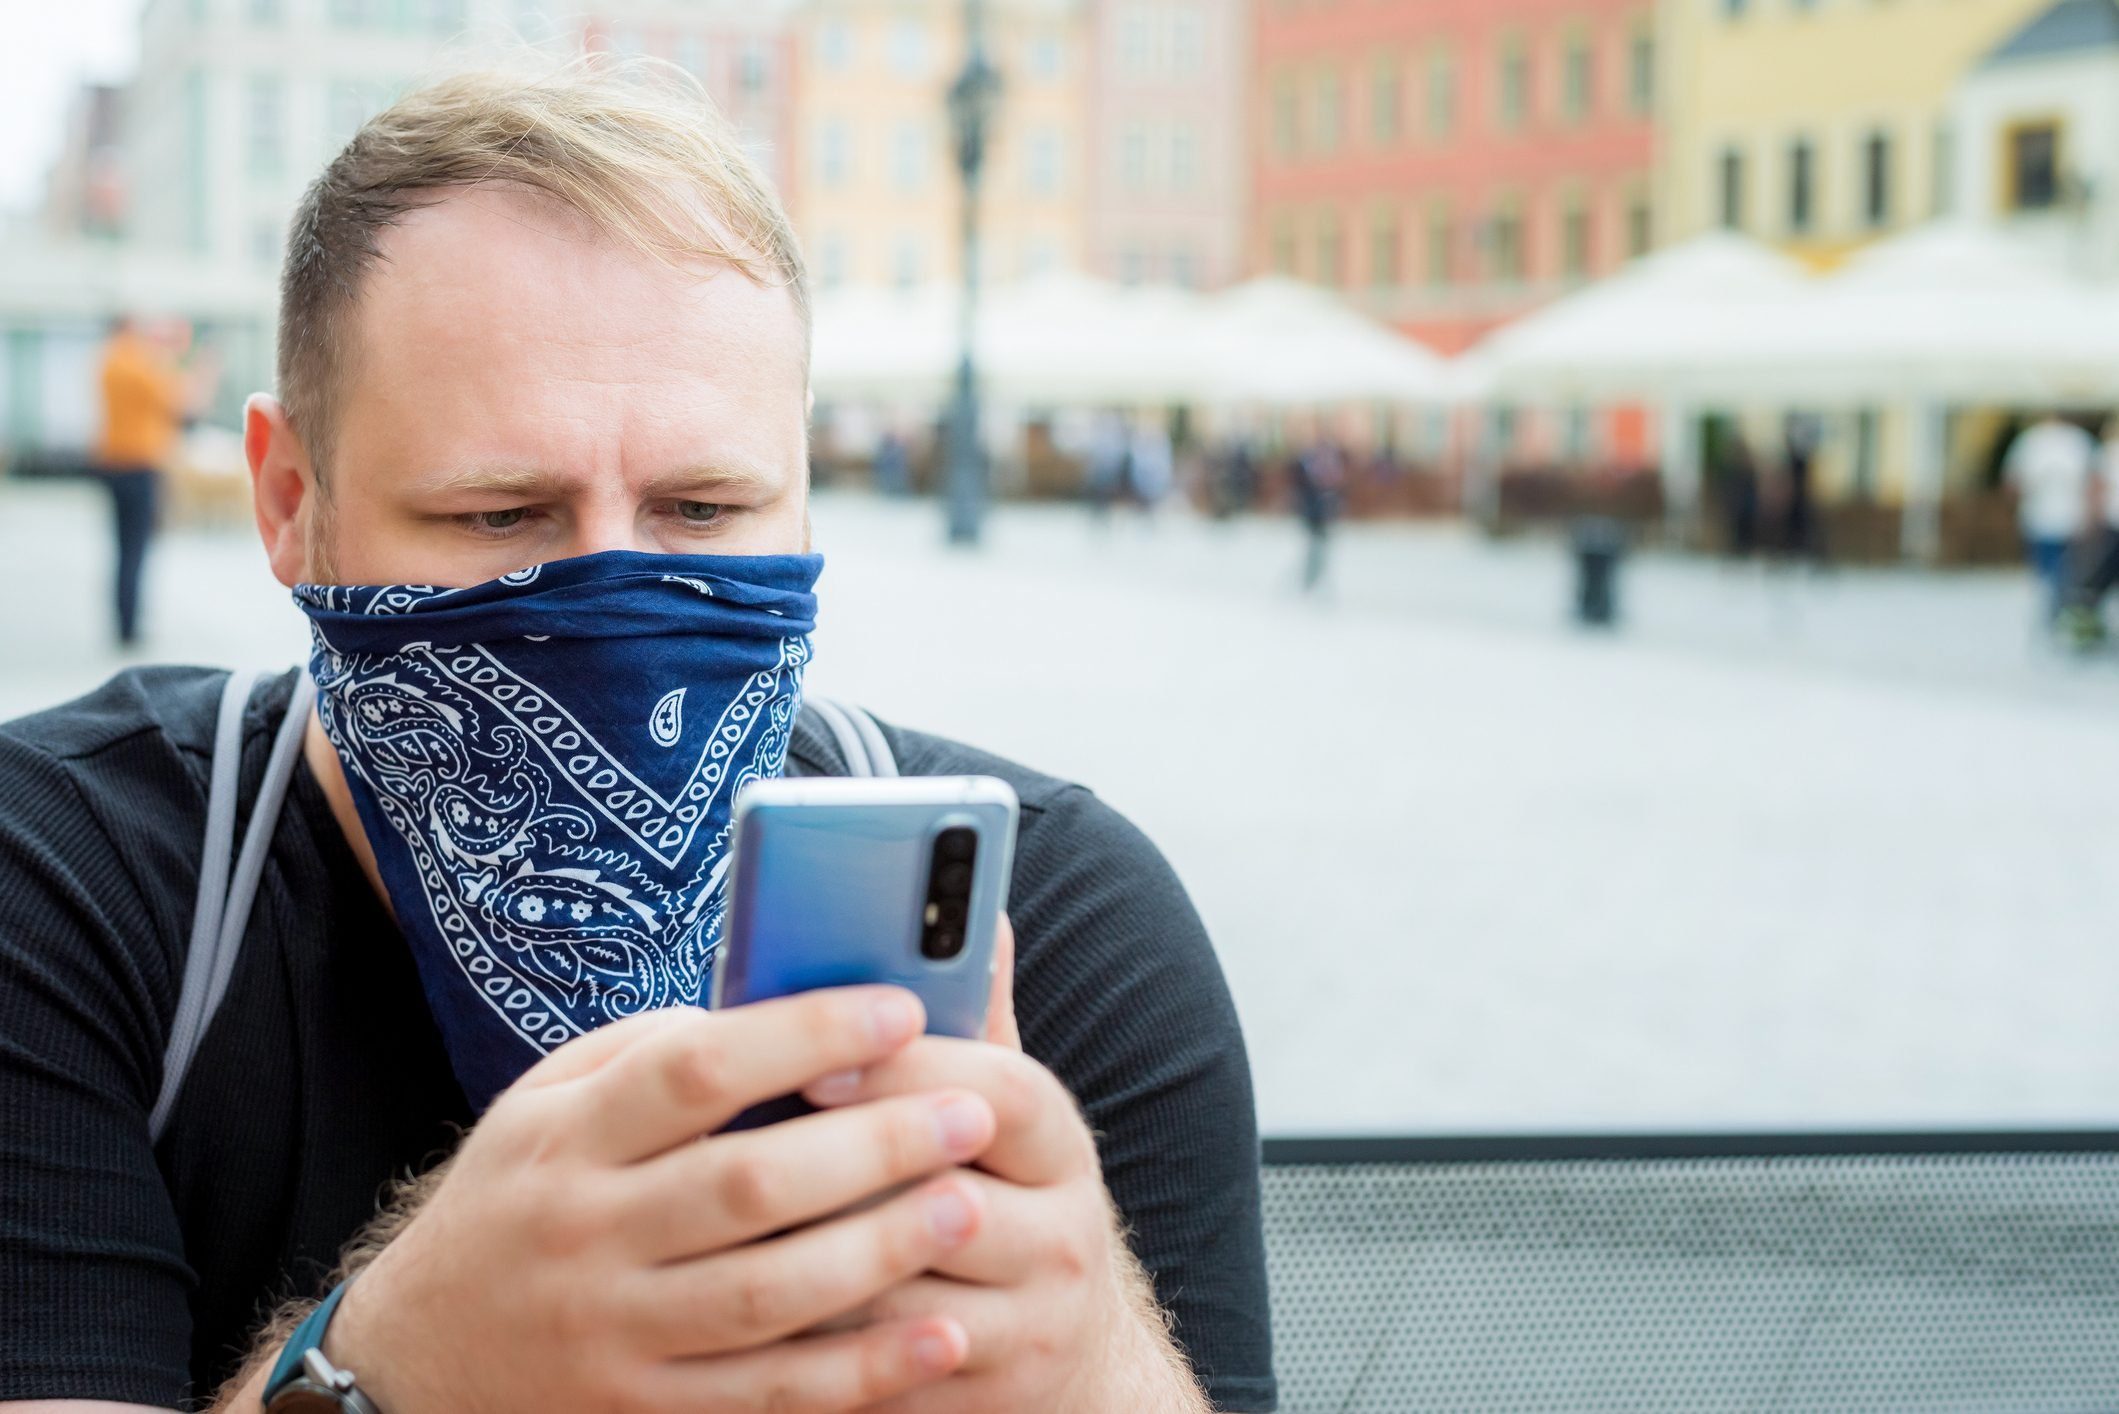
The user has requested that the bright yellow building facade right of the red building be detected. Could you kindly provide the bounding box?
[1657,0,2051,265]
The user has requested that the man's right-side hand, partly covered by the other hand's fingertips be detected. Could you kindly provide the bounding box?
[803,1018,1206,1414]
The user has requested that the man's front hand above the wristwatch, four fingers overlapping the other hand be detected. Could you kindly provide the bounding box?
[326,988,1000,1414]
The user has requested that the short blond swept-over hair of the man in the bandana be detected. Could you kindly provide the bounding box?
[278,55,809,473]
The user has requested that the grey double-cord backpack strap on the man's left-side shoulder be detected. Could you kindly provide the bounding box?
[146,672,316,1141]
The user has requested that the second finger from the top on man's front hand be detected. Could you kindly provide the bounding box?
[619,1090,996,1261]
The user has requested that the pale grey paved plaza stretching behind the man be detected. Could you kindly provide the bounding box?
[0,485,2119,1132]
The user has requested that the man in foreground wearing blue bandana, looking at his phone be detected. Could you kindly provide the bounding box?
[0,68,1274,1414]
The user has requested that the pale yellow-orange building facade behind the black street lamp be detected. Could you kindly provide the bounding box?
[786,0,1089,288]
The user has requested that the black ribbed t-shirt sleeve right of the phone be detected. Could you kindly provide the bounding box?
[1009,786,1276,1410]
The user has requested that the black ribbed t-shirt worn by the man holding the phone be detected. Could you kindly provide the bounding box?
[0,668,1274,1410]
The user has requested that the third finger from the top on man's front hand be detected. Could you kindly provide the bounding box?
[621,1174,983,1357]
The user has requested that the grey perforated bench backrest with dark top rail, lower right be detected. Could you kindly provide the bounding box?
[1265,1134,2119,1414]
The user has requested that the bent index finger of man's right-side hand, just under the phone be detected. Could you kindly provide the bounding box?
[803,1037,1096,1183]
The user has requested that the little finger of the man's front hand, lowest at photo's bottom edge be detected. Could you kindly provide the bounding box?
[655,1316,971,1414]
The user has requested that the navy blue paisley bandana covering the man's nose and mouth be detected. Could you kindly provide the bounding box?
[295,551,822,1111]
